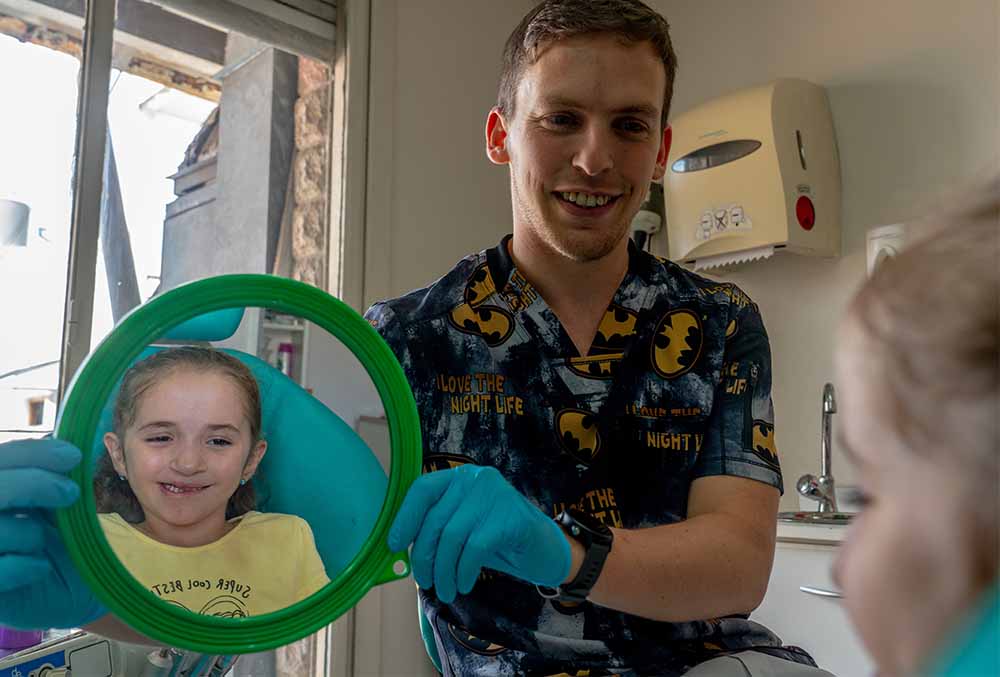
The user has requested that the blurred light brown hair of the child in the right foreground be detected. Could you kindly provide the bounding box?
[847,177,1000,527]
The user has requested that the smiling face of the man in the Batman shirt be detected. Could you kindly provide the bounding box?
[487,35,668,261]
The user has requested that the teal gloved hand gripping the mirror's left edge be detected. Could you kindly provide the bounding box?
[0,439,107,630]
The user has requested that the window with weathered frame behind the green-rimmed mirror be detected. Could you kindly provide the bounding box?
[0,0,354,674]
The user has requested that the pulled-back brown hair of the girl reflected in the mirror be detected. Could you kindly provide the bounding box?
[94,346,261,524]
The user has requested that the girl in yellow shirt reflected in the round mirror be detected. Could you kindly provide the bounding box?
[94,347,329,617]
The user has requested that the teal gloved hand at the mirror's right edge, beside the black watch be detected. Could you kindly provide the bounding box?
[389,465,570,604]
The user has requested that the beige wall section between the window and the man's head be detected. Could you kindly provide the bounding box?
[365,0,534,304]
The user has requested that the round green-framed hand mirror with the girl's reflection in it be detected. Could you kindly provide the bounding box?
[0,275,420,654]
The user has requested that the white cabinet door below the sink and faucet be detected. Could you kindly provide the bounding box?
[751,542,874,677]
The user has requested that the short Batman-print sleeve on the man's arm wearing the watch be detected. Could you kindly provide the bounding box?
[692,289,784,492]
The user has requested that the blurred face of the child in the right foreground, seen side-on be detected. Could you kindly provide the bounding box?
[834,327,975,677]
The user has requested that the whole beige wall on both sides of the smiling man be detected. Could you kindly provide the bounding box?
[365,0,1000,509]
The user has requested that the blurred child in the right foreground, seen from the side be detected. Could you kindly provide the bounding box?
[835,180,1000,676]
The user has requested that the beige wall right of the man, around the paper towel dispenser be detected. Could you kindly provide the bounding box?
[650,0,1000,509]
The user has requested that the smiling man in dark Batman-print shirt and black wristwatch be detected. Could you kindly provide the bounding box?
[367,0,828,675]
